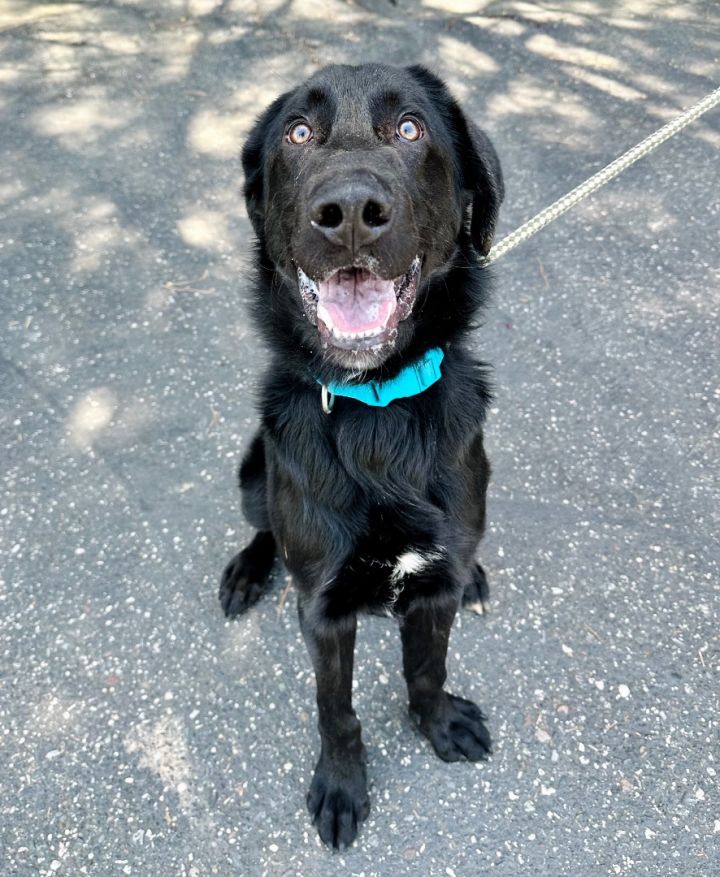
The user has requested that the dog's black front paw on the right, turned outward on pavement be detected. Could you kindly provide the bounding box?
[410,691,492,761]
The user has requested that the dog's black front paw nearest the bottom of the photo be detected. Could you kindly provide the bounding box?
[307,758,370,850]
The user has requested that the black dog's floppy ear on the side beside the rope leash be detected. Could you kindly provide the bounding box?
[408,65,505,256]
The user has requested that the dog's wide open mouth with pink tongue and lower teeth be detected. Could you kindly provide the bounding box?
[297,256,421,350]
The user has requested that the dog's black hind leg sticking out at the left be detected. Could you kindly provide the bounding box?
[219,433,275,618]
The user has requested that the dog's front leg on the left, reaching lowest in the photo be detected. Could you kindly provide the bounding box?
[298,598,370,849]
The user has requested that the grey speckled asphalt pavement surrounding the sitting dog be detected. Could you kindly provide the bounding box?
[0,0,720,877]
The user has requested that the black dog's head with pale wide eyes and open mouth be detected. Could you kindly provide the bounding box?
[243,65,503,372]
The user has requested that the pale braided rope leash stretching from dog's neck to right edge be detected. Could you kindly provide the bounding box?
[482,88,720,265]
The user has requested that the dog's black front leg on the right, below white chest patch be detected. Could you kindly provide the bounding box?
[400,601,490,761]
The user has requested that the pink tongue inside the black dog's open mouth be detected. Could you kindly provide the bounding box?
[317,268,397,335]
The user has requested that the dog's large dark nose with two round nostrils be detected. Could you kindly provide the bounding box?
[309,180,392,255]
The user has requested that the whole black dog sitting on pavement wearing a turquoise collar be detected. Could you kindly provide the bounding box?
[220,65,503,846]
